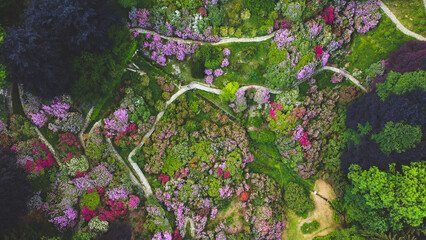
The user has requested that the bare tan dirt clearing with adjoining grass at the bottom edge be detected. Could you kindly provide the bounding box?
[281,179,339,240]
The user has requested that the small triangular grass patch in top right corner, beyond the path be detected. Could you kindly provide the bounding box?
[382,0,426,37]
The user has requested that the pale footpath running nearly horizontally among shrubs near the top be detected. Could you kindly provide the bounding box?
[130,28,275,46]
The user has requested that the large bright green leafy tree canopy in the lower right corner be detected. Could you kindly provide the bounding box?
[345,162,426,232]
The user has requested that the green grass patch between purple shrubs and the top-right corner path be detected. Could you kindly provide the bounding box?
[339,12,415,72]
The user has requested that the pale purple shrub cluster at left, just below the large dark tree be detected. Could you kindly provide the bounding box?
[21,92,83,134]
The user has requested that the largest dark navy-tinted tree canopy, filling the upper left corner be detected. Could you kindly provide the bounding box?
[1,0,120,97]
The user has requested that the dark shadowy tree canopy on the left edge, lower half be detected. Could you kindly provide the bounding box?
[0,147,32,236]
